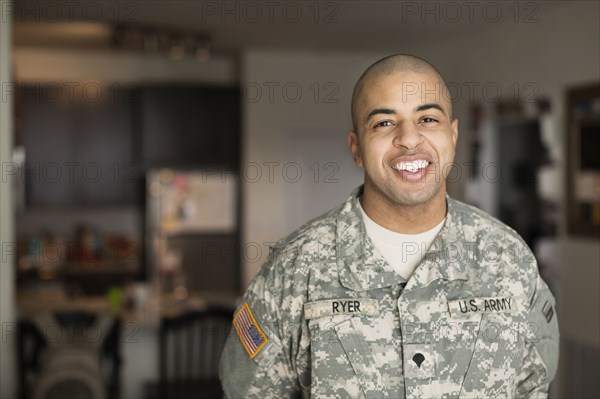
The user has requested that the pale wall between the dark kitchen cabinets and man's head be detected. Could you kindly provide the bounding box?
[242,50,373,286]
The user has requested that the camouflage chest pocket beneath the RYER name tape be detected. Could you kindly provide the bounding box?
[309,316,389,399]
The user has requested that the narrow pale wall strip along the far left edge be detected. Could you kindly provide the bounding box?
[0,1,16,398]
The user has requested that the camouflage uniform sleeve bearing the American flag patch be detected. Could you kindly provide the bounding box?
[219,248,299,399]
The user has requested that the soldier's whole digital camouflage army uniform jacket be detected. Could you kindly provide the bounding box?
[220,187,558,399]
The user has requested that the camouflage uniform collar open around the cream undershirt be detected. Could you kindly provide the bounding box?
[336,186,467,291]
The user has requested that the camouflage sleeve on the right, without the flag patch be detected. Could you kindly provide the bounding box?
[516,274,559,398]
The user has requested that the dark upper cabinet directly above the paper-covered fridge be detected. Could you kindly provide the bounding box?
[140,85,240,168]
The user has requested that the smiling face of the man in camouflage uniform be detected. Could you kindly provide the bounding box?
[348,72,458,206]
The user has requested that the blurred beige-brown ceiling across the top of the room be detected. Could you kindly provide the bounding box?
[14,0,564,53]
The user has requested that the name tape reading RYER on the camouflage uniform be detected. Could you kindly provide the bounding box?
[304,298,379,320]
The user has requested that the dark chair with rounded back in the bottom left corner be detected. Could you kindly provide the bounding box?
[17,312,121,399]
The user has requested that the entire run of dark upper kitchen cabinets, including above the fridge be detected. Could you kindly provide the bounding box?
[20,85,240,207]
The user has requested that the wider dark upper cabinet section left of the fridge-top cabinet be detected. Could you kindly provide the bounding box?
[20,87,143,207]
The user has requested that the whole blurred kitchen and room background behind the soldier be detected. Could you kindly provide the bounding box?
[0,0,600,399]
